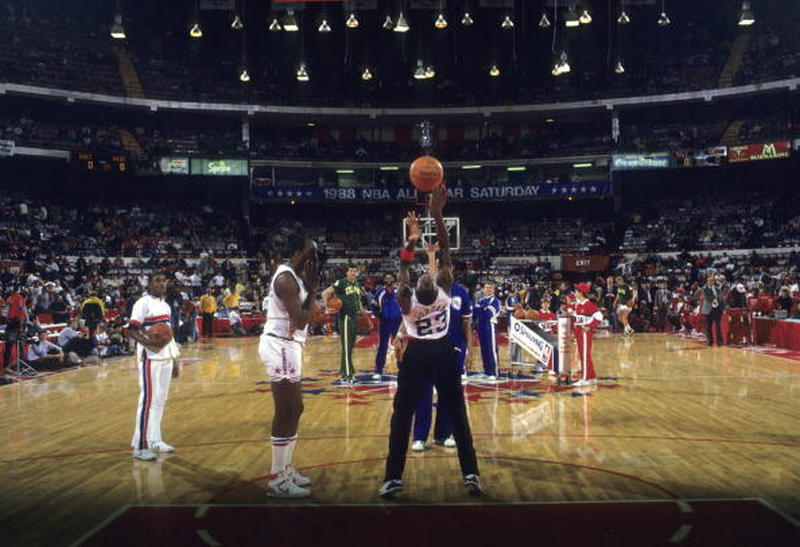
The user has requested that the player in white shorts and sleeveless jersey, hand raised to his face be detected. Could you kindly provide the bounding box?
[258,235,319,498]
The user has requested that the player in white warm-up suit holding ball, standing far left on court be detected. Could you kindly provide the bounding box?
[129,274,179,461]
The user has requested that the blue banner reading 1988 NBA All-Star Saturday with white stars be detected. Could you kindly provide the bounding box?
[252,180,613,202]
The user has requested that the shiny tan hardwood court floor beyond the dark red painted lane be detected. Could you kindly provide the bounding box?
[0,334,800,546]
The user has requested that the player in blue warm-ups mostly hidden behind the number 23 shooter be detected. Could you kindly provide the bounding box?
[411,246,472,452]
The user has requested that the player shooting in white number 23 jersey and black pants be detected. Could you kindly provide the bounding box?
[378,188,482,498]
